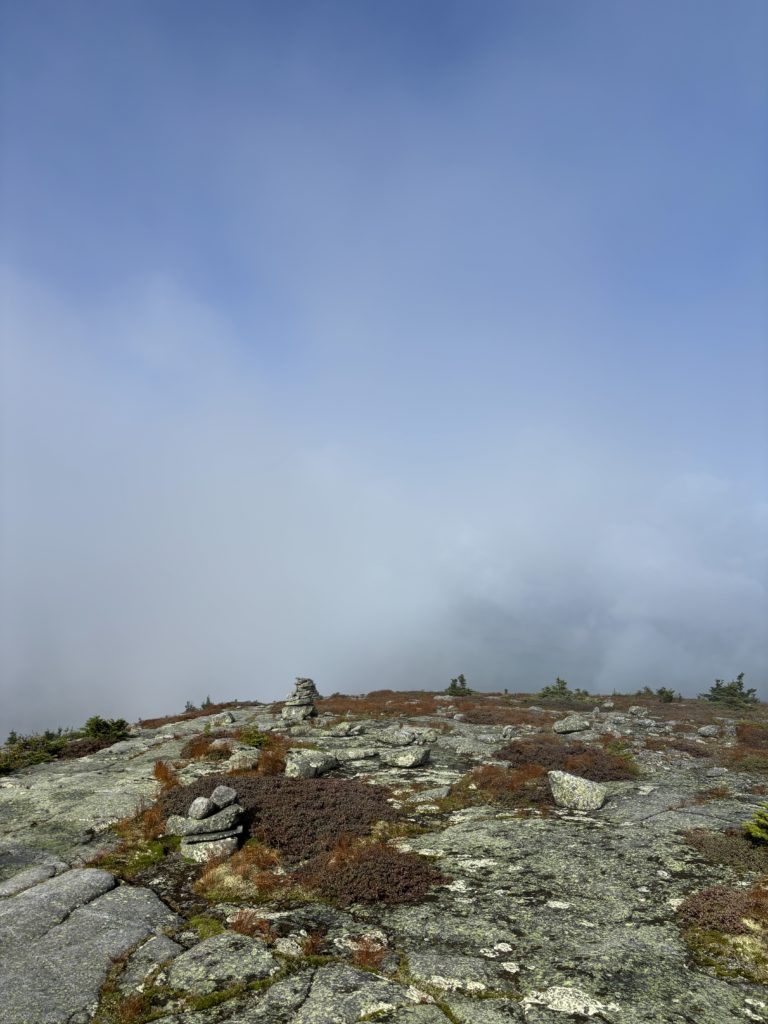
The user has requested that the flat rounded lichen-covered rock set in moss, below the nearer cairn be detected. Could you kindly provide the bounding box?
[166,932,280,995]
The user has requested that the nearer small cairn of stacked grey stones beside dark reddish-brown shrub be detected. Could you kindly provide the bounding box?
[166,785,243,863]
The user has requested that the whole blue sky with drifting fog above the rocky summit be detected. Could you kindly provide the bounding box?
[0,0,768,728]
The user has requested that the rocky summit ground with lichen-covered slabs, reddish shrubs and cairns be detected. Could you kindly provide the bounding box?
[0,679,768,1024]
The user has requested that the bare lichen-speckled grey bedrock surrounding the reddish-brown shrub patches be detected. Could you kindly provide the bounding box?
[0,698,768,1024]
